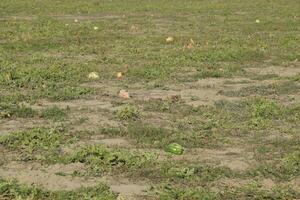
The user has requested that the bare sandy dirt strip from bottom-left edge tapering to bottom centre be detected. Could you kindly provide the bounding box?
[0,162,149,199]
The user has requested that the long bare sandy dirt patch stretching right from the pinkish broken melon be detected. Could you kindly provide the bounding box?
[129,77,274,106]
